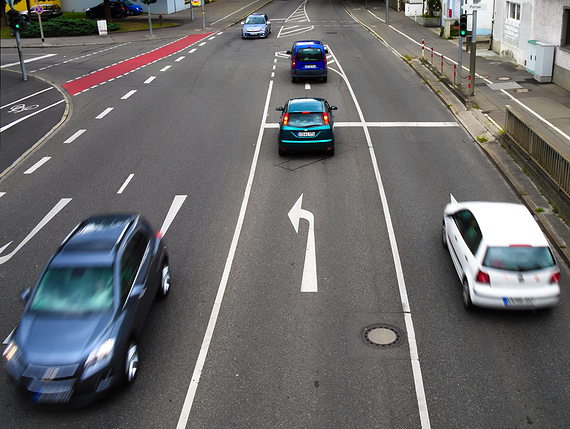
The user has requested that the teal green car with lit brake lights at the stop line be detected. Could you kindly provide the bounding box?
[275,98,337,156]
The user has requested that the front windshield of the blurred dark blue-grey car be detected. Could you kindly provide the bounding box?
[30,267,113,313]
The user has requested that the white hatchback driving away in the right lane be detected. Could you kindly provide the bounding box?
[442,196,560,309]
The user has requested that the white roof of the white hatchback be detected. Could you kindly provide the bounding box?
[455,201,548,246]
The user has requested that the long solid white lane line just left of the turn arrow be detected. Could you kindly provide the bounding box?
[176,81,273,429]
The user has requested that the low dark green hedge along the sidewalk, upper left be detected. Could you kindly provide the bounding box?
[20,17,121,37]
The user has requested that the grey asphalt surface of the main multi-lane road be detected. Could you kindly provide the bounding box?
[0,0,570,428]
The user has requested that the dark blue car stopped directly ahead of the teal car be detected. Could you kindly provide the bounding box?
[287,40,329,83]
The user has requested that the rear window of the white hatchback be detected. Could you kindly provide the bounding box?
[483,246,555,271]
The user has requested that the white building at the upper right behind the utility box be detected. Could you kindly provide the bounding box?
[492,0,570,90]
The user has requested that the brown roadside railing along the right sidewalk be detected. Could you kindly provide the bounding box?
[505,105,570,199]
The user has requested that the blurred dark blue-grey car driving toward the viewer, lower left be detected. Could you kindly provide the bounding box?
[3,214,170,404]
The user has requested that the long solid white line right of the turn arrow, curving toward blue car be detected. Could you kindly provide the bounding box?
[331,46,431,429]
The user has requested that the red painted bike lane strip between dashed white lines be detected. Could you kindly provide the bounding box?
[63,33,212,95]
